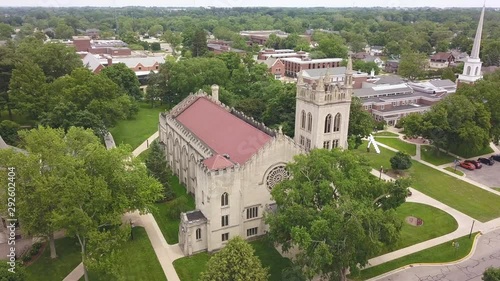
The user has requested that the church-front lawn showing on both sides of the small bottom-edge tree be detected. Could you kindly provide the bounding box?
[174,239,291,281]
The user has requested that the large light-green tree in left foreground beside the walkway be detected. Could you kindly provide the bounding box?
[0,127,161,281]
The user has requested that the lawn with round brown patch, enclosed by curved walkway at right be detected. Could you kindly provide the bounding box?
[393,202,458,251]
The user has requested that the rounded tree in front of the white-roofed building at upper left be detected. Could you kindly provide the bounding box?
[99,63,142,100]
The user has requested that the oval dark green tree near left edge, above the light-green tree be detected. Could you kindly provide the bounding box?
[9,60,50,119]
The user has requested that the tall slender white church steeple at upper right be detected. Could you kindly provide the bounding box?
[457,5,485,84]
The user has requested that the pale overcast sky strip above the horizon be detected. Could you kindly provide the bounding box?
[0,0,494,8]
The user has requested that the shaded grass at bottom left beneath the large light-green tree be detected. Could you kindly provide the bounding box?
[26,237,82,281]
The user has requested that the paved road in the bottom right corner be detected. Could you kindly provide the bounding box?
[374,229,500,281]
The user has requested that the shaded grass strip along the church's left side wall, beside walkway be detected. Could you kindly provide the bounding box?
[152,175,195,244]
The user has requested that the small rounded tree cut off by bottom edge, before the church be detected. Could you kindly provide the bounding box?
[200,236,269,281]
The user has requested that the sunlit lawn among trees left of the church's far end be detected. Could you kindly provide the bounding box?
[109,103,166,149]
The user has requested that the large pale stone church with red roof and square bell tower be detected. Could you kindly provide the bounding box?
[159,58,352,255]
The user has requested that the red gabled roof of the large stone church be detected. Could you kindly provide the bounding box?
[176,97,271,169]
